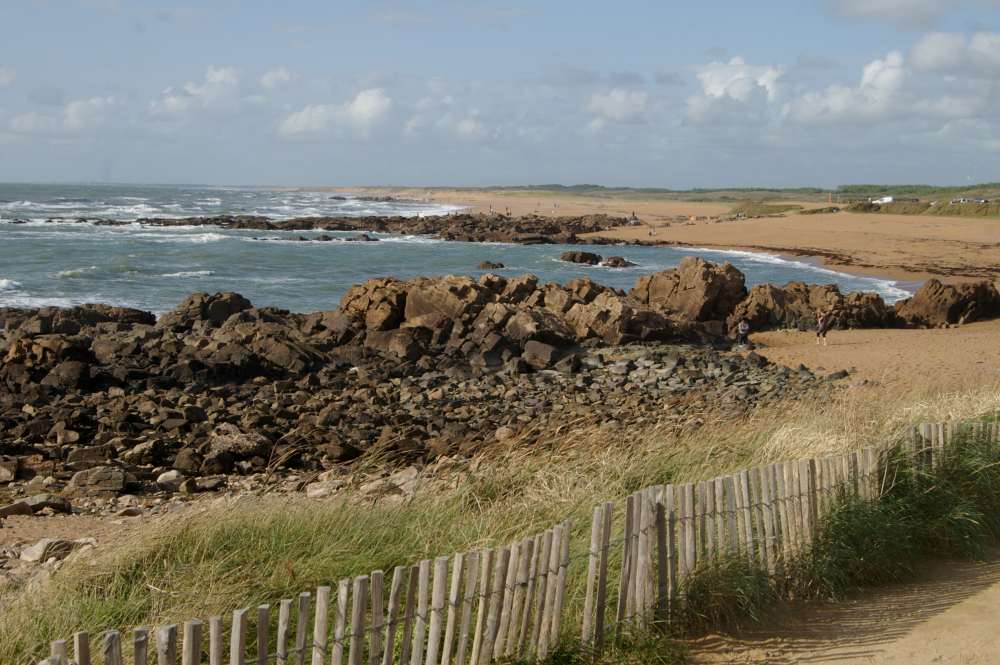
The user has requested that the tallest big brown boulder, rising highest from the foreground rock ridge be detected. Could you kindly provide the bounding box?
[629,256,747,321]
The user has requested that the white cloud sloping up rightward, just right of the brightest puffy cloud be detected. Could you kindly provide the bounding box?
[786,51,906,122]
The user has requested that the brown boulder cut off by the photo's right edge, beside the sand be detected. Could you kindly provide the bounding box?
[896,279,1000,326]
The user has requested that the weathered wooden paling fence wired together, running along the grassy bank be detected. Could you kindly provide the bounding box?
[42,421,1000,665]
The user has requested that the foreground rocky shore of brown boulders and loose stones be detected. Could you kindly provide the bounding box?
[0,249,1000,516]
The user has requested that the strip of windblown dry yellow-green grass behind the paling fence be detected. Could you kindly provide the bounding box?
[0,386,1000,664]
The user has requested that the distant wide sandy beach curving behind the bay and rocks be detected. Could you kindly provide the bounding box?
[351,187,1000,285]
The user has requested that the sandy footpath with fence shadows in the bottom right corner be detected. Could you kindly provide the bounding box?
[692,552,1000,665]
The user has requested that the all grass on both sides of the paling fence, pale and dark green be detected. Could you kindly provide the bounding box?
[0,387,1000,665]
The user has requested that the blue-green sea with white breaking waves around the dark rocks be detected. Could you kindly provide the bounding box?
[0,184,910,313]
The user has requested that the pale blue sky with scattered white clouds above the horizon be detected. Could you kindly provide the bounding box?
[0,0,1000,188]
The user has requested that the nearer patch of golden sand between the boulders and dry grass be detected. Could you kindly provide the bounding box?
[751,320,1000,391]
